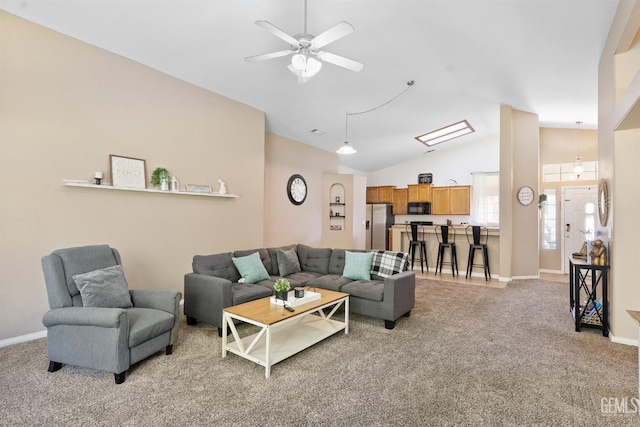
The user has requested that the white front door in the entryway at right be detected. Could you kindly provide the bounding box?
[562,186,598,273]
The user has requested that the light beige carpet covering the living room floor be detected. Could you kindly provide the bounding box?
[0,275,640,426]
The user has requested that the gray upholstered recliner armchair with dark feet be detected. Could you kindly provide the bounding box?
[42,245,182,384]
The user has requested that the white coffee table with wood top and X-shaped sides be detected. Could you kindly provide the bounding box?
[222,289,349,378]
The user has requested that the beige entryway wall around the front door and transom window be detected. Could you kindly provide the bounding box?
[540,128,598,272]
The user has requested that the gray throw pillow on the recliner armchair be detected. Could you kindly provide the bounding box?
[72,265,133,308]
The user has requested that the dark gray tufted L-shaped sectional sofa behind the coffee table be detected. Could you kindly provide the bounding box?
[184,244,415,335]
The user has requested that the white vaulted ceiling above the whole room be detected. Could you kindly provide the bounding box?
[0,0,618,172]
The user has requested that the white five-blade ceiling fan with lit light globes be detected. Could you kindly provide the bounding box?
[245,0,364,83]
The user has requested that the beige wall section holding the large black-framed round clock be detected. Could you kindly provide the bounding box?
[264,133,338,247]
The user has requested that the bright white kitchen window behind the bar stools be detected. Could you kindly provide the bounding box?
[471,172,500,226]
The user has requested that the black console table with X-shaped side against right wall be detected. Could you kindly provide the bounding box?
[569,258,609,337]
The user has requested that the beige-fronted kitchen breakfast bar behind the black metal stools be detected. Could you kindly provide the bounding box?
[390,224,500,279]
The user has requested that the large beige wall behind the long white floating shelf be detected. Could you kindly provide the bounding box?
[0,11,264,340]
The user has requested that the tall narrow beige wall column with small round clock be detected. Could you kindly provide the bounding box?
[500,106,540,280]
